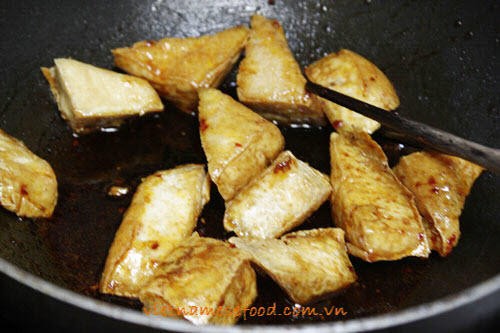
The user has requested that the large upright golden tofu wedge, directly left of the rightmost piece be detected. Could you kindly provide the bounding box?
[330,132,430,262]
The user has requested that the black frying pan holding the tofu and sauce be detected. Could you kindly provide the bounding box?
[0,0,500,331]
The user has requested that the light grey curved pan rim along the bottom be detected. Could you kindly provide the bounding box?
[0,257,500,332]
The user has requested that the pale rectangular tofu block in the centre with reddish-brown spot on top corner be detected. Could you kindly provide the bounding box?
[224,151,331,238]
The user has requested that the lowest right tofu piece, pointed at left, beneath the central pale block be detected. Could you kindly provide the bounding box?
[229,228,356,304]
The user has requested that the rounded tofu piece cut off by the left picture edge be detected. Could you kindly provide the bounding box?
[0,130,57,218]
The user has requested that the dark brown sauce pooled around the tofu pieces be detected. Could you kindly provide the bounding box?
[29,79,428,325]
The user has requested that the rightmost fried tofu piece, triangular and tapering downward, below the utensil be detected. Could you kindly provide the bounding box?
[394,152,483,257]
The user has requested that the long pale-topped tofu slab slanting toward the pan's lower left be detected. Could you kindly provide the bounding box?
[99,164,210,297]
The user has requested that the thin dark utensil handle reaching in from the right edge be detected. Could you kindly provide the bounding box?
[306,80,500,174]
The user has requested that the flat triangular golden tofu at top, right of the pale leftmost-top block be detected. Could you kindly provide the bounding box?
[112,26,249,114]
